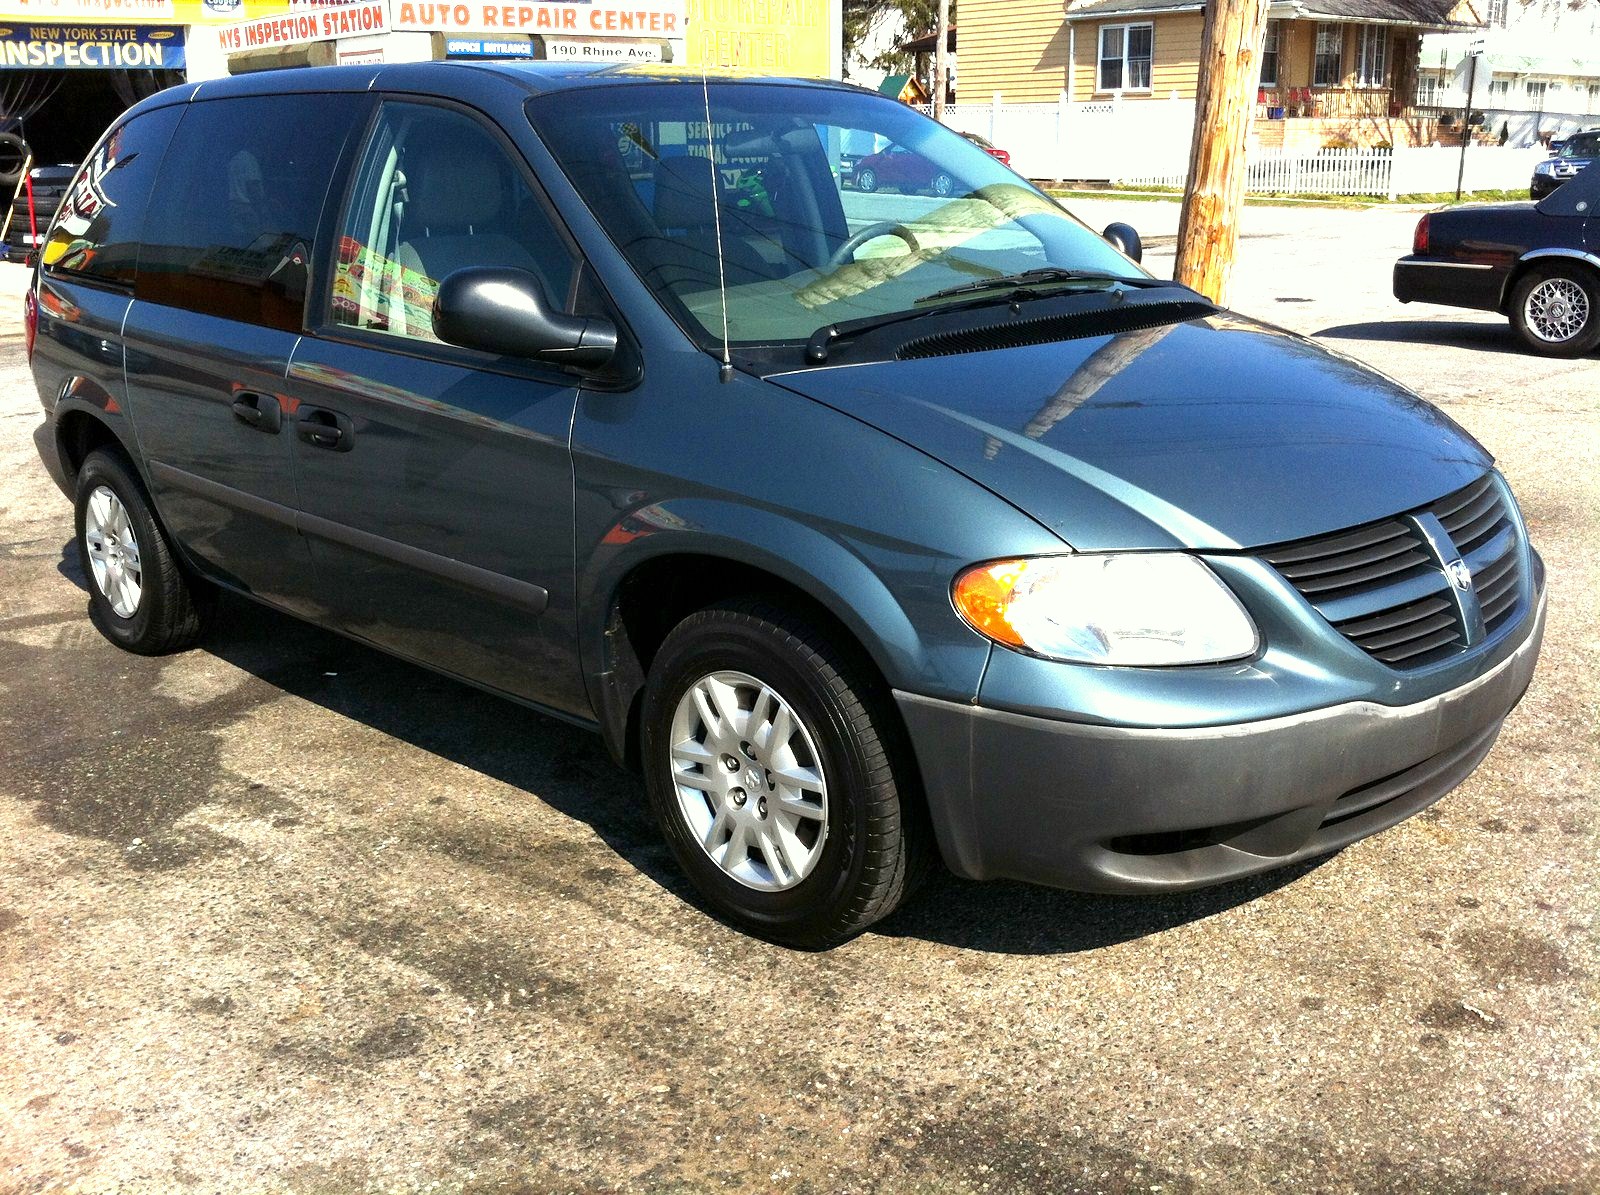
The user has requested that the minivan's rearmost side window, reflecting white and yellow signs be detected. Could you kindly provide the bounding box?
[40,107,182,285]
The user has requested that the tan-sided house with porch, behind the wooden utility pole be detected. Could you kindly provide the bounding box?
[960,0,1482,144]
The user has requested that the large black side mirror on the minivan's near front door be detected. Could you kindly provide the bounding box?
[434,266,616,370]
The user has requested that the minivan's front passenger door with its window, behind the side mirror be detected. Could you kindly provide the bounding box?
[288,101,589,715]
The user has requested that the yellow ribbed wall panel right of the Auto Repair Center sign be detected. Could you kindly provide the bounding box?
[686,0,837,78]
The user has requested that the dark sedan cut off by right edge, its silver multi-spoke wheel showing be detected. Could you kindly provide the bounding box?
[1394,170,1600,357]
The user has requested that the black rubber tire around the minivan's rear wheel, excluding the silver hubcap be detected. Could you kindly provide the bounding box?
[75,448,211,656]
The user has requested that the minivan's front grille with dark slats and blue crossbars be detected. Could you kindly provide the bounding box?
[1261,474,1523,669]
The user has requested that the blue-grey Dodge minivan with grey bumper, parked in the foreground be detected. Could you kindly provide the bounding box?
[27,62,1544,947]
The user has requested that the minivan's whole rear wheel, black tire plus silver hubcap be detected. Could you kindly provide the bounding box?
[77,448,210,656]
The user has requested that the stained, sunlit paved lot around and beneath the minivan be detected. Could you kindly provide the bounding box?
[0,202,1600,1192]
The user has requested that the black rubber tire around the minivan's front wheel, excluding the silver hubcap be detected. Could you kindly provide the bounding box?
[642,598,931,950]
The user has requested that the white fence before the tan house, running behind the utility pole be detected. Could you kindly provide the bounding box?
[944,99,1544,198]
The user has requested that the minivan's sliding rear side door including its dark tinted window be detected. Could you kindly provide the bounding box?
[125,94,371,617]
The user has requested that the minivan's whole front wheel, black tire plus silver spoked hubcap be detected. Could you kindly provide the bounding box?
[642,600,928,949]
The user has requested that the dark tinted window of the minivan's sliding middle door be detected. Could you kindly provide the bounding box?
[136,94,368,331]
